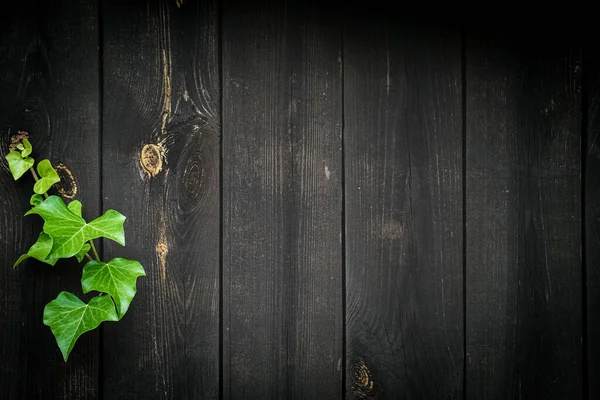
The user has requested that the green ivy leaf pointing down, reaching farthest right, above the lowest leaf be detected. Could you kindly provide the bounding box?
[81,258,146,319]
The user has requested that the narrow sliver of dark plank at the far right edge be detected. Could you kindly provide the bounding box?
[582,41,600,399]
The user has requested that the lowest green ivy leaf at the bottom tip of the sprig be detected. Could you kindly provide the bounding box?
[44,292,119,361]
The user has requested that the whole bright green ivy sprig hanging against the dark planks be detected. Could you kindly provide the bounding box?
[6,138,146,362]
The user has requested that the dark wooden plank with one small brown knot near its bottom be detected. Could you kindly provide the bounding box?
[344,15,463,399]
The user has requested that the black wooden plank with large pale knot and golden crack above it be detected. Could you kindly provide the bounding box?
[103,1,220,399]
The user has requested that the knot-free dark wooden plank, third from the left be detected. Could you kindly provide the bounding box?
[223,1,343,399]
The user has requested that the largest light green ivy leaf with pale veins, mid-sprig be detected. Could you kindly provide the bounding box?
[25,196,125,258]
